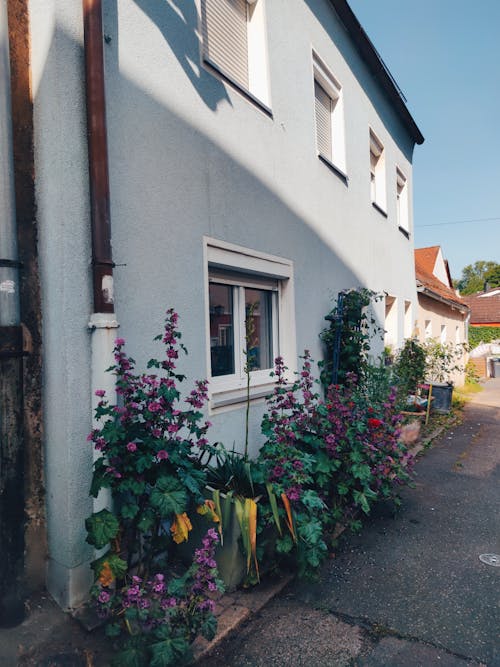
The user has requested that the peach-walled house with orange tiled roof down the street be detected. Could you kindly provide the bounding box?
[415,246,469,384]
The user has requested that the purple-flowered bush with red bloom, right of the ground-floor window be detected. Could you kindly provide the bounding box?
[260,351,412,576]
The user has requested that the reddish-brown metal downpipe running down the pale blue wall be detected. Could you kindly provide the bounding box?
[82,0,114,313]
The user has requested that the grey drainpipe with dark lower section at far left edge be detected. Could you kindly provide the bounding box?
[0,0,24,627]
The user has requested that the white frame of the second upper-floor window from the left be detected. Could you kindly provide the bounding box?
[313,51,346,176]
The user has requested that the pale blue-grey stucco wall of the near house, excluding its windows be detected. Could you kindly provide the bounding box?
[31,0,416,605]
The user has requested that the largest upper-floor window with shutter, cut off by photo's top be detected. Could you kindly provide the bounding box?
[201,0,269,105]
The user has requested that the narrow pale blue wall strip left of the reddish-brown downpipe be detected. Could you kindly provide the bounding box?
[30,0,92,607]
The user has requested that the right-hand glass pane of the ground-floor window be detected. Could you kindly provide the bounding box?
[245,288,273,371]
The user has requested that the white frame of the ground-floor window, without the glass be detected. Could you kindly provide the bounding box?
[203,237,296,409]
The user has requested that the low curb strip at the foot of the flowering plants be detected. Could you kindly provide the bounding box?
[193,574,294,663]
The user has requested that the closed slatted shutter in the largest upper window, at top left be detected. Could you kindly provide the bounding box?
[201,0,248,89]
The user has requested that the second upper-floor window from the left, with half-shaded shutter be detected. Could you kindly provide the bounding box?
[313,54,346,174]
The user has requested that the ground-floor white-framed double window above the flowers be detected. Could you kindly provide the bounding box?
[205,239,295,407]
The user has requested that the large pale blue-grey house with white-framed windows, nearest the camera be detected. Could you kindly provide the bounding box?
[1,0,424,607]
